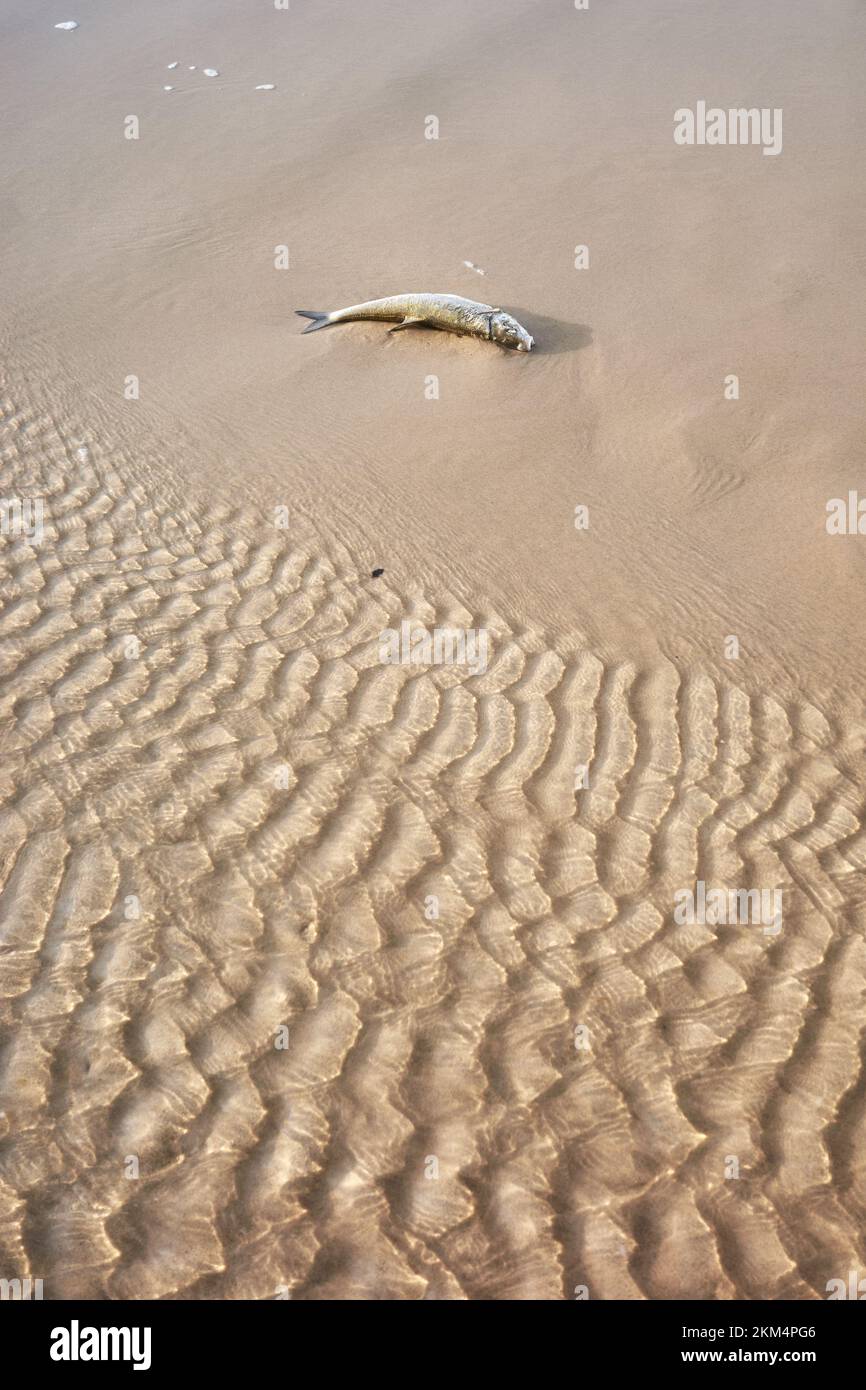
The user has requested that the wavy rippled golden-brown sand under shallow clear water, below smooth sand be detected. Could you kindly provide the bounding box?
[0,400,866,1300]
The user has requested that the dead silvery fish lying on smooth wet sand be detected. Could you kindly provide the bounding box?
[295,295,534,352]
